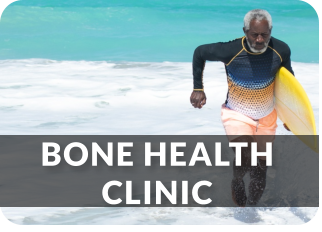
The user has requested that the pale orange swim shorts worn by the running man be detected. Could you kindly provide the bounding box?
[221,104,277,142]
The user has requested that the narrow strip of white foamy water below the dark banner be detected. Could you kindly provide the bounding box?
[1,207,318,225]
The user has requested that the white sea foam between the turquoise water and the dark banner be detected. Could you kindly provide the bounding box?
[0,59,319,135]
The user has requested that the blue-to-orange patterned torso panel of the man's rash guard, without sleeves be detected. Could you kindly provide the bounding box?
[226,38,282,120]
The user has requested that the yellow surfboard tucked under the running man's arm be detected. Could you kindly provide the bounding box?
[275,67,319,153]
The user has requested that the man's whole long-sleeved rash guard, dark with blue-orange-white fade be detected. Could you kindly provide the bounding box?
[193,37,294,120]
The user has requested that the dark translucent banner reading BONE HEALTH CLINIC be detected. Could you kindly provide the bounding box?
[0,135,319,207]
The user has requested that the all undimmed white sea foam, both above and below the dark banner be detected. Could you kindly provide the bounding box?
[0,59,319,224]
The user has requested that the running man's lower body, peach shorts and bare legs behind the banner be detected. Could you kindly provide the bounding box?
[221,105,277,206]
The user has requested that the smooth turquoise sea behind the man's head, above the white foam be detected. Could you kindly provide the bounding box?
[0,0,319,63]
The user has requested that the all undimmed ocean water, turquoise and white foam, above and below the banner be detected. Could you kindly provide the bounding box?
[0,0,319,225]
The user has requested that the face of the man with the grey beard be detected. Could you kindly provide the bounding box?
[244,19,271,53]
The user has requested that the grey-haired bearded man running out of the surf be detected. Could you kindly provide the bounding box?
[190,9,294,207]
